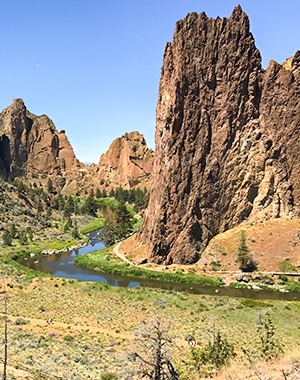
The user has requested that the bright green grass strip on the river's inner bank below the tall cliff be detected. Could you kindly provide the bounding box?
[74,248,222,286]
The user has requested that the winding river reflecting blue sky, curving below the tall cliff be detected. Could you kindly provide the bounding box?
[18,227,300,300]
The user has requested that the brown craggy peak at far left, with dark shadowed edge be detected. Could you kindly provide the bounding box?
[0,99,81,184]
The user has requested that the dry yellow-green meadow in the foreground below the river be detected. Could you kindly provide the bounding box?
[0,272,300,379]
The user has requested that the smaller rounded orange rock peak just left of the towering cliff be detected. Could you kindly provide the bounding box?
[95,132,154,189]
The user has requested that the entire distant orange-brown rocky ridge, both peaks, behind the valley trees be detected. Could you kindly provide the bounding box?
[0,99,153,194]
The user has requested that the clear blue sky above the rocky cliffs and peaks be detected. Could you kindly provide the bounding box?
[0,0,300,163]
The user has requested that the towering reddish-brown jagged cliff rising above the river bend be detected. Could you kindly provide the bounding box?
[138,6,300,264]
